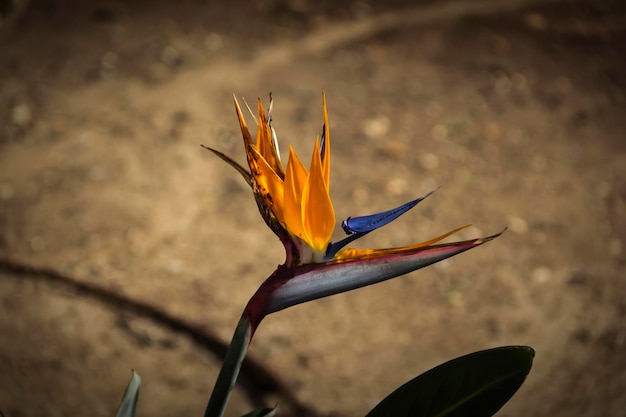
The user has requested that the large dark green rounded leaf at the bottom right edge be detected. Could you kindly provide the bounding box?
[367,346,535,417]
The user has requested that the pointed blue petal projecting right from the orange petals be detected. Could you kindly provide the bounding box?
[325,188,439,259]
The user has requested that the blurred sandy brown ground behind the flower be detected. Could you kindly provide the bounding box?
[0,0,626,417]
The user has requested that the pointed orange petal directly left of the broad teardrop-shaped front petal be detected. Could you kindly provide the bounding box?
[284,146,309,239]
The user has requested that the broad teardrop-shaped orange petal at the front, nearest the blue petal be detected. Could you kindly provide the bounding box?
[302,140,335,251]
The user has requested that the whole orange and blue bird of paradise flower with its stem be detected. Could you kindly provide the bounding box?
[205,95,502,416]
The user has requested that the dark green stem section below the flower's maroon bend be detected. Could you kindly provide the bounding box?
[204,317,252,417]
